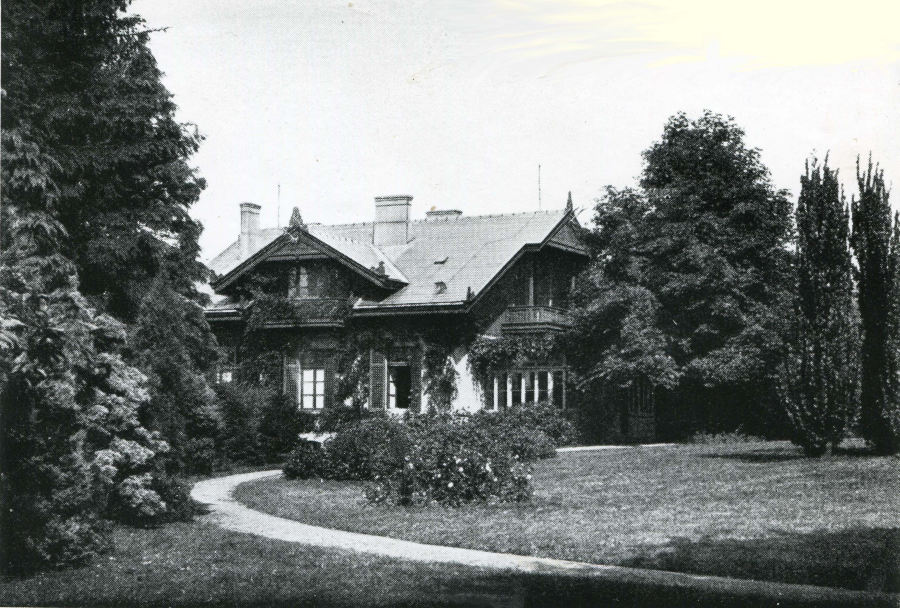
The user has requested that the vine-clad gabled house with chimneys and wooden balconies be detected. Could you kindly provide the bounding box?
[206,195,620,422]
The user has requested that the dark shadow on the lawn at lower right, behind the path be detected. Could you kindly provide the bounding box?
[622,528,900,593]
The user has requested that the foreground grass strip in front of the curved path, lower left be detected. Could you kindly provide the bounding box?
[0,523,525,607]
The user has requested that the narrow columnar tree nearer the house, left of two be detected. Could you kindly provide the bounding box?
[786,157,857,456]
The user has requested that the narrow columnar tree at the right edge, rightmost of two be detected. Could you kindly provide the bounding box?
[852,157,900,454]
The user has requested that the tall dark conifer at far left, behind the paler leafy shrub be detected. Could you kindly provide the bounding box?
[2,0,216,470]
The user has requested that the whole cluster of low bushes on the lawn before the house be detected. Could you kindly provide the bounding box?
[284,405,575,505]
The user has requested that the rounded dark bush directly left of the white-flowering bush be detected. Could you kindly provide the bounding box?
[320,418,412,481]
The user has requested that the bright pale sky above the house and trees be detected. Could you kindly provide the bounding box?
[131,0,900,258]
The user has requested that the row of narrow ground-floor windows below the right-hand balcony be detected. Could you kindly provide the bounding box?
[484,368,566,410]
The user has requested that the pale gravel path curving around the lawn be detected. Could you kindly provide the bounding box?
[191,470,900,606]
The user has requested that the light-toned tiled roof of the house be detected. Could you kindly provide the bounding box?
[209,209,580,310]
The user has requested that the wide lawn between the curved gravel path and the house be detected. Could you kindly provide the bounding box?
[237,442,900,592]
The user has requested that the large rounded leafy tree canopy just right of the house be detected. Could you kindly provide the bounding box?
[573,111,792,436]
